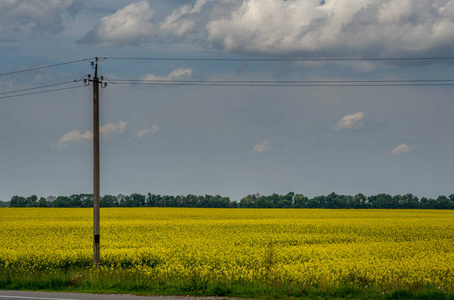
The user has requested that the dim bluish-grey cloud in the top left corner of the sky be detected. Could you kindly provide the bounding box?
[0,0,83,34]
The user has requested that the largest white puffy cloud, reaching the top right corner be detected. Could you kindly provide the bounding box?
[206,0,454,56]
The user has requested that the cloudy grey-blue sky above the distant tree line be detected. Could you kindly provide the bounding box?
[0,0,454,201]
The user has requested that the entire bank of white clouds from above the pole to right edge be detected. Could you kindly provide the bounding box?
[81,0,454,57]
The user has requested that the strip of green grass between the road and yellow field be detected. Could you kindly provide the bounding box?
[0,267,454,300]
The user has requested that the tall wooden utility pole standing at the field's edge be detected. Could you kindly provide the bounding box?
[93,57,100,268]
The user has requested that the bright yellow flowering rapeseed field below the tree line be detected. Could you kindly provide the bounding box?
[0,208,454,288]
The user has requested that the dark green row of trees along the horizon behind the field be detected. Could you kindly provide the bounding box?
[0,192,454,209]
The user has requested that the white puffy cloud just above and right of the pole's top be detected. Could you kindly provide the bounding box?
[79,1,154,46]
